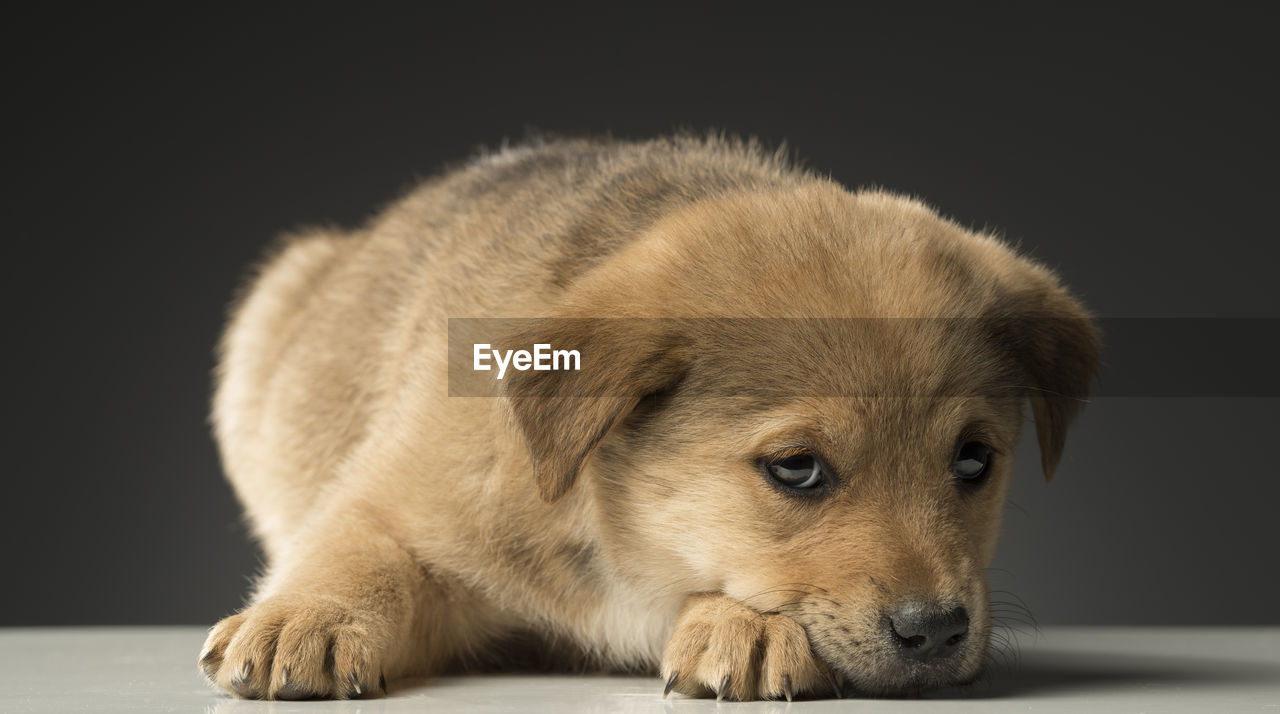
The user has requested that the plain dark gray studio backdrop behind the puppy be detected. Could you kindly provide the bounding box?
[0,3,1280,624]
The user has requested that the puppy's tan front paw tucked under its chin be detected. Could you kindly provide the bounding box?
[662,595,836,701]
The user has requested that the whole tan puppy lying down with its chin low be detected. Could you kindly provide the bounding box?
[200,137,1097,699]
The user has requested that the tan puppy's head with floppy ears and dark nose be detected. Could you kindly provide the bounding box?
[507,184,1098,694]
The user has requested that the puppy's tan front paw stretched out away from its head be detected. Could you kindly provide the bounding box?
[200,598,387,699]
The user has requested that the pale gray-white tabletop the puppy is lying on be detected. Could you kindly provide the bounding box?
[0,627,1280,714]
